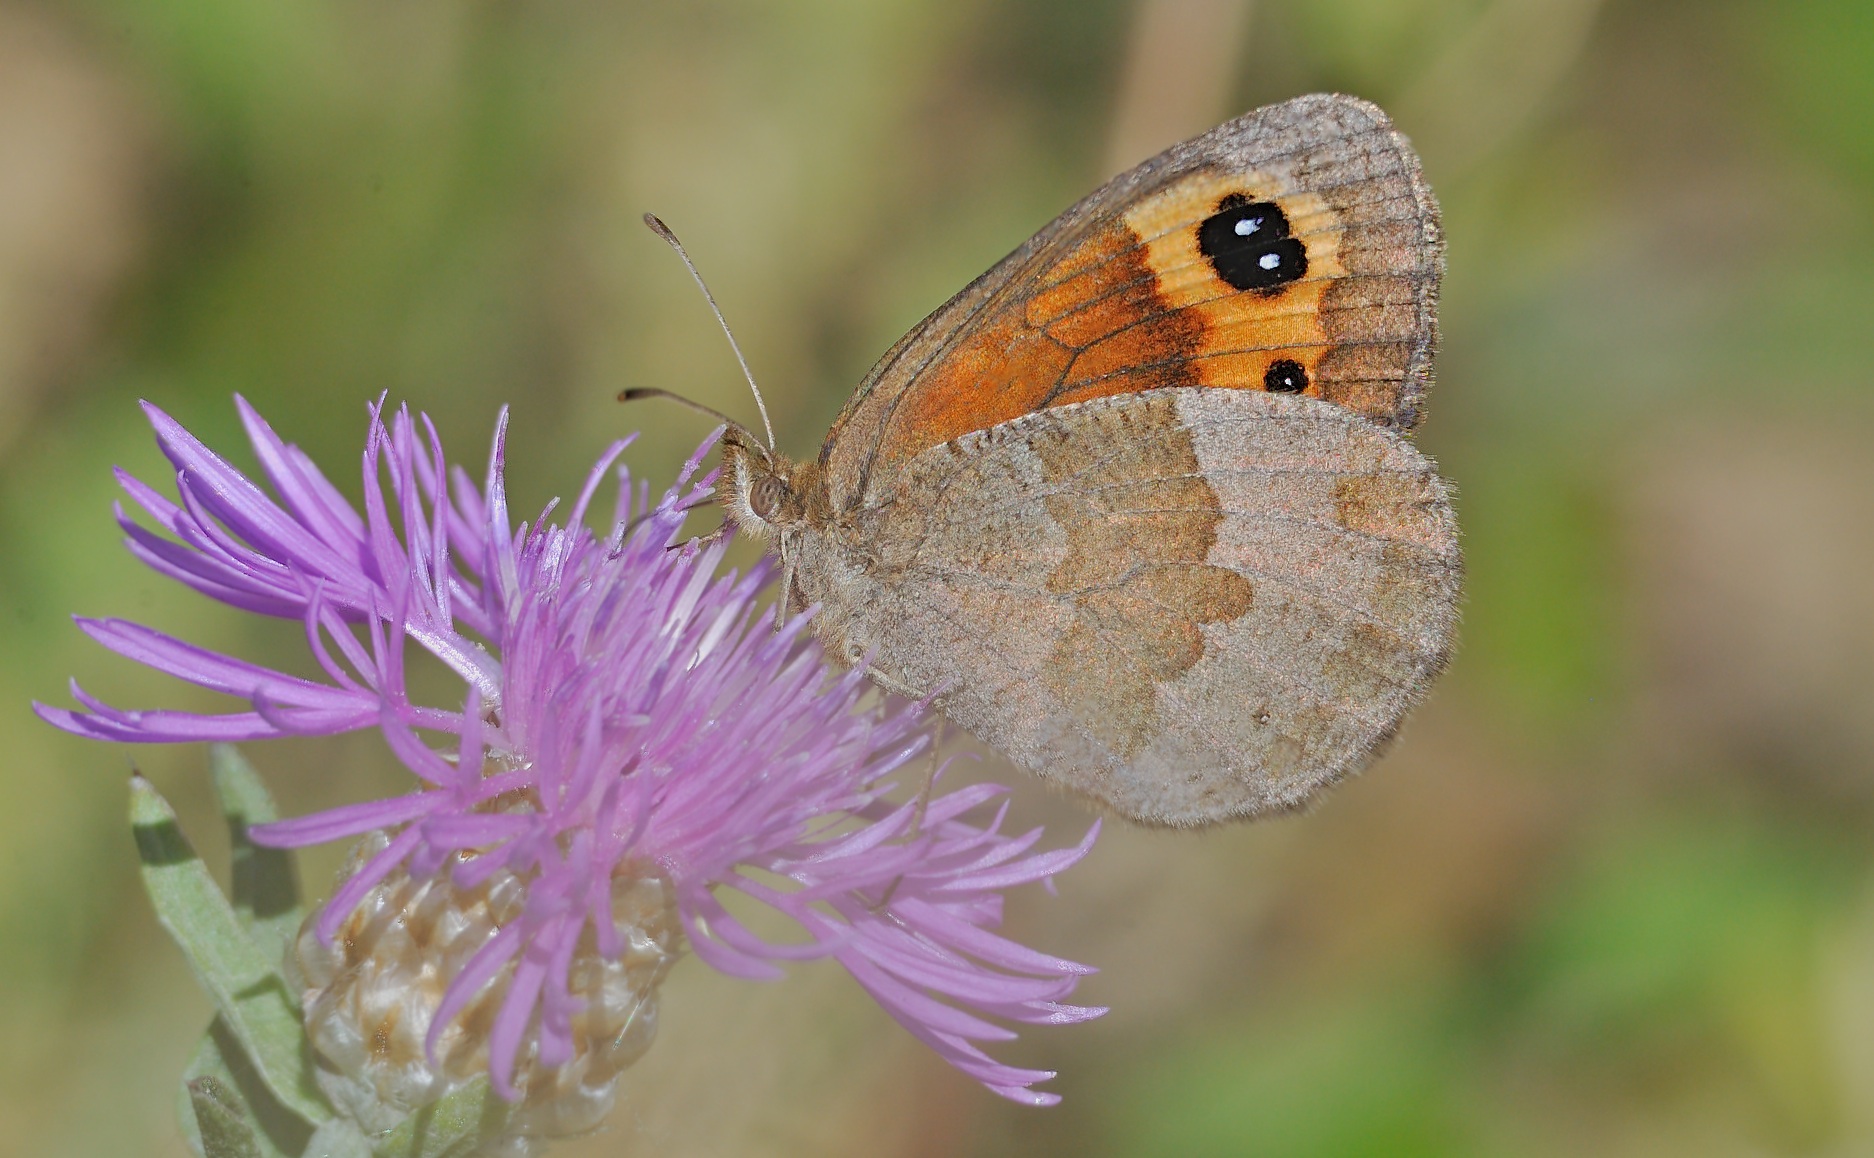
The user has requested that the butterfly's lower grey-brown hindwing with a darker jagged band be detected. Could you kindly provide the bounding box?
[796,388,1460,824]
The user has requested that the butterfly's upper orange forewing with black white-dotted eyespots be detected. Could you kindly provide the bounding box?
[821,96,1443,510]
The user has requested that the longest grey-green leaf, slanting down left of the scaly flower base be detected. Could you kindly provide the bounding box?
[129,776,332,1122]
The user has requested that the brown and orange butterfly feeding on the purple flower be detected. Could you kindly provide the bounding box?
[697,96,1462,826]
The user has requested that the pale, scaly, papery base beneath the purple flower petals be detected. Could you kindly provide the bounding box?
[299,834,684,1158]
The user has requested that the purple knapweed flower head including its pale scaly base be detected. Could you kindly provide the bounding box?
[37,399,1104,1124]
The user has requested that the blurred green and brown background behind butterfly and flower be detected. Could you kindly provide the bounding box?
[0,0,1874,1158]
